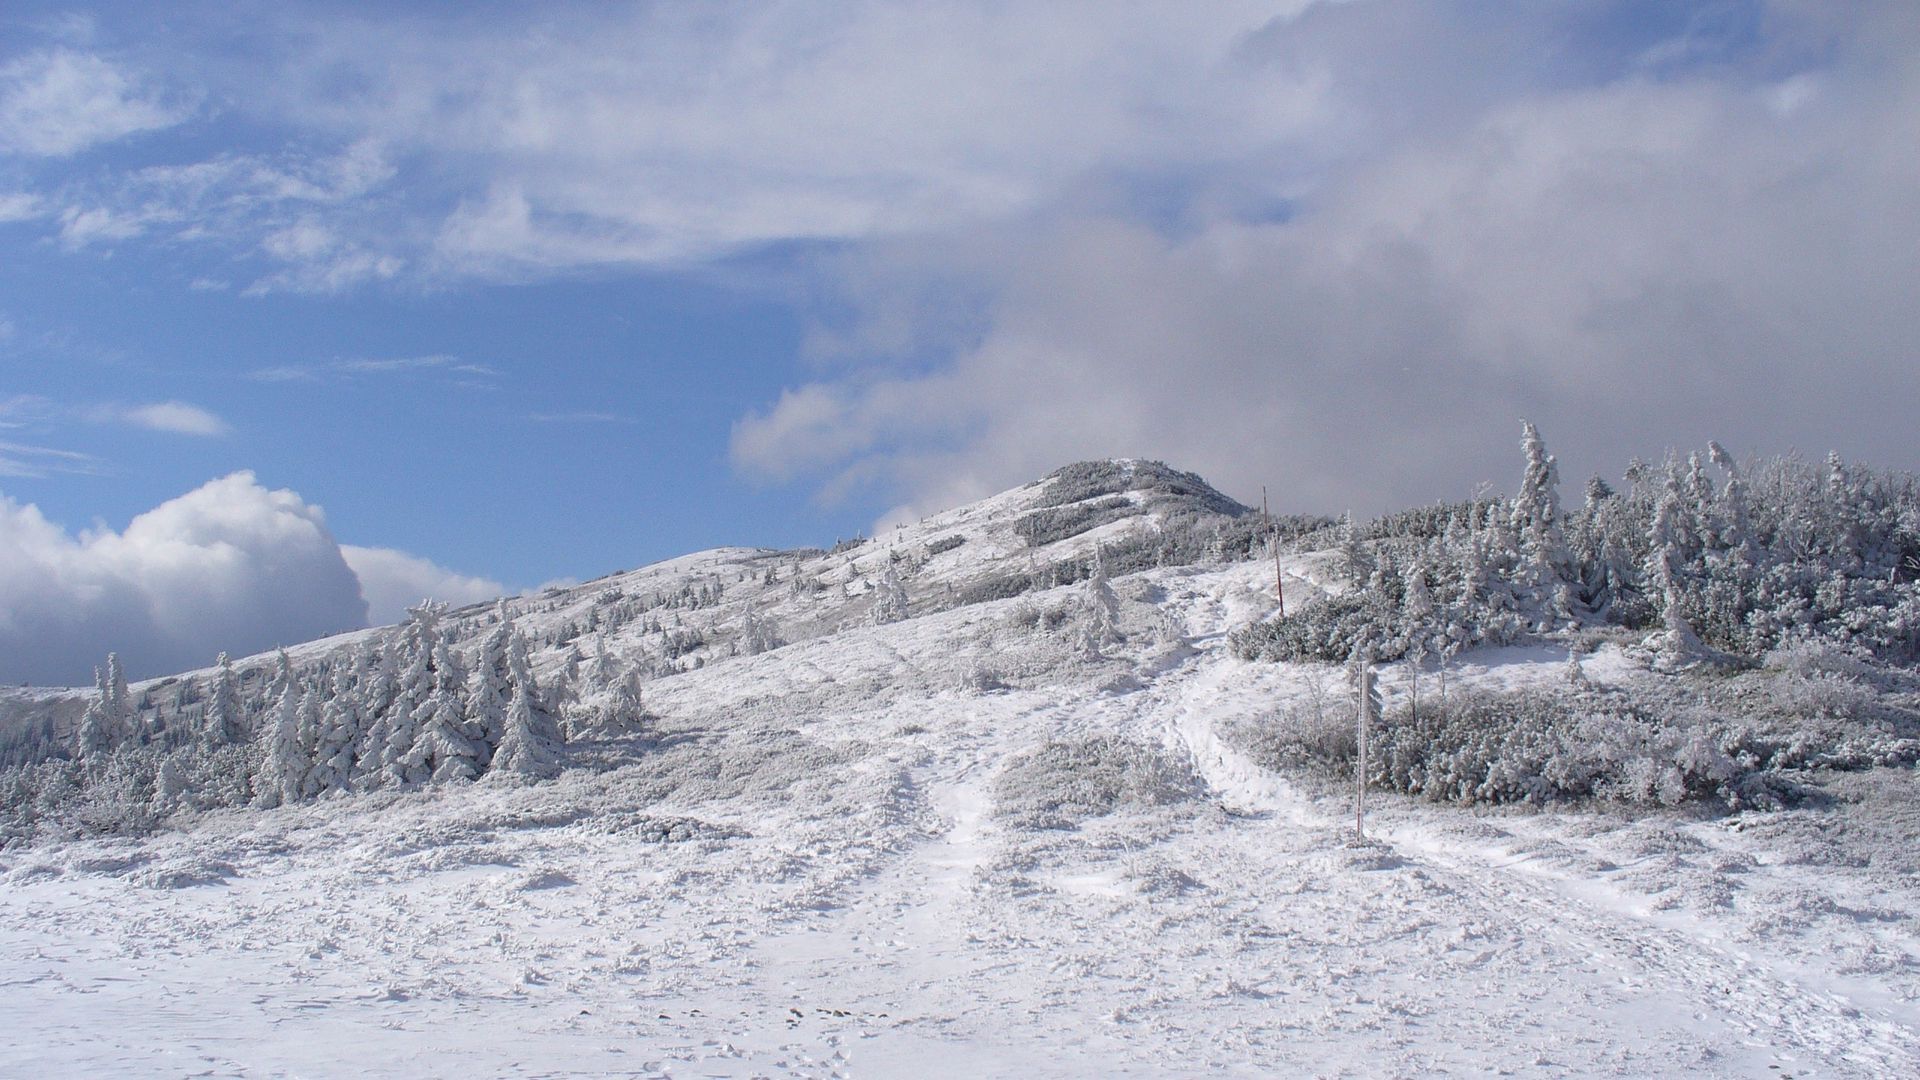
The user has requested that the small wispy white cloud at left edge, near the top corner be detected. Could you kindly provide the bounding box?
[0,48,188,158]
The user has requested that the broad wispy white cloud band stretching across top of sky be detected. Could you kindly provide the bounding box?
[3,0,1317,278]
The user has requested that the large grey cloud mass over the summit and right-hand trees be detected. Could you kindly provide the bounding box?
[733,0,1920,513]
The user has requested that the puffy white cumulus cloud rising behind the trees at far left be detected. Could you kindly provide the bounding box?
[0,473,367,684]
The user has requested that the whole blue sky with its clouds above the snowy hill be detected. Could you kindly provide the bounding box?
[0,0,1920,678]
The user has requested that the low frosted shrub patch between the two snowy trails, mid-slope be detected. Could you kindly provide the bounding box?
[993,736,1194,828]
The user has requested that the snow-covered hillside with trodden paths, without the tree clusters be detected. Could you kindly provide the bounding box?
[0,461,1920,1078]
